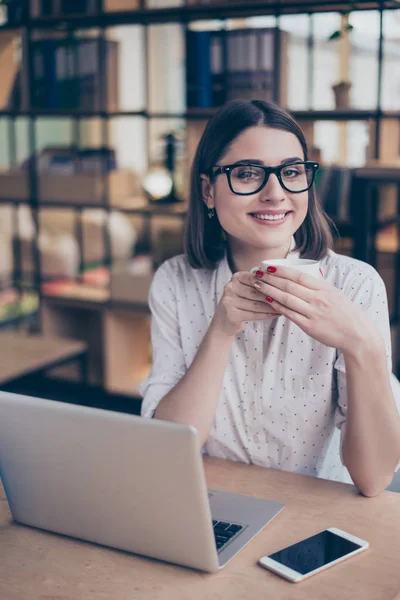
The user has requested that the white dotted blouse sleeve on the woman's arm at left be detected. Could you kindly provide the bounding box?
[139,262,186,418]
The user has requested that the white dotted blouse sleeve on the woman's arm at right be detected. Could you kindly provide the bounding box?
[335,267,400,461]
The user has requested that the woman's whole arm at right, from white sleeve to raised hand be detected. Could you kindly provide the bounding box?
[250,267,400,496]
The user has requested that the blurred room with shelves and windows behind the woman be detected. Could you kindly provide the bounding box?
[0,0,400,422]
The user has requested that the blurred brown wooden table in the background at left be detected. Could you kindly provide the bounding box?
[0,332,87,384]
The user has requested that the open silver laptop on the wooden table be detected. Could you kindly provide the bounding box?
[0,392,283,572]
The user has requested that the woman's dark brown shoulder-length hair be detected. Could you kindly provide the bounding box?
[184,100,332,269]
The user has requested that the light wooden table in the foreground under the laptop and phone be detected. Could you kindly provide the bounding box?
[0,458,400,600]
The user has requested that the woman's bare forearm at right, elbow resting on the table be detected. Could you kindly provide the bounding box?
[342,331,400,496]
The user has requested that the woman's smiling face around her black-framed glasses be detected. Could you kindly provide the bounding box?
[203,126,308,258]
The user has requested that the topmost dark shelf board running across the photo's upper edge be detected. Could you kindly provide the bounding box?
[0,0,399,30]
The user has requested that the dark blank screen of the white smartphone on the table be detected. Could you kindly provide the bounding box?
[269,531,360,575]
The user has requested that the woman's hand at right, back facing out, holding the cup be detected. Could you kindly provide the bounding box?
[254,266,380,352]
